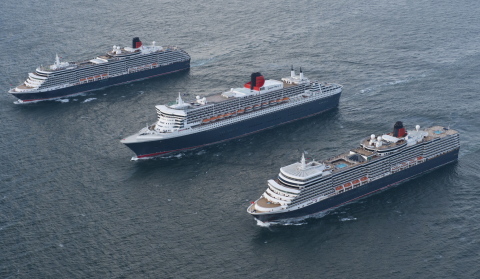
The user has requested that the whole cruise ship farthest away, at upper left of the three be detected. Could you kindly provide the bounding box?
[8,37,190,104]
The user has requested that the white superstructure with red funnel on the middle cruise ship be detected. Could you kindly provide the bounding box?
[122,69,342,143]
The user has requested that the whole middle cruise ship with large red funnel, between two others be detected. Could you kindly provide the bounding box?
[121,67,342,160]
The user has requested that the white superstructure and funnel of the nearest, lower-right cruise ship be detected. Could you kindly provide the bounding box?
[248,122,460,215]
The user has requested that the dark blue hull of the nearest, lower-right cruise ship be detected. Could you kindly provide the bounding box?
[254,148,459,222]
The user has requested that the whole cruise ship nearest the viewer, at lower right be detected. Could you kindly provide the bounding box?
[247,121,460,223]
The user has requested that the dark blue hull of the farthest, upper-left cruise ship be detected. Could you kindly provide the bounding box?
[10,60,190,103]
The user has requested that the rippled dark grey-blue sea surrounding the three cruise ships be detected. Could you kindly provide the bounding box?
[0,0,480,278]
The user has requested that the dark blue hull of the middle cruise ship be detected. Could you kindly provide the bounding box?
[125,93,341,158]
